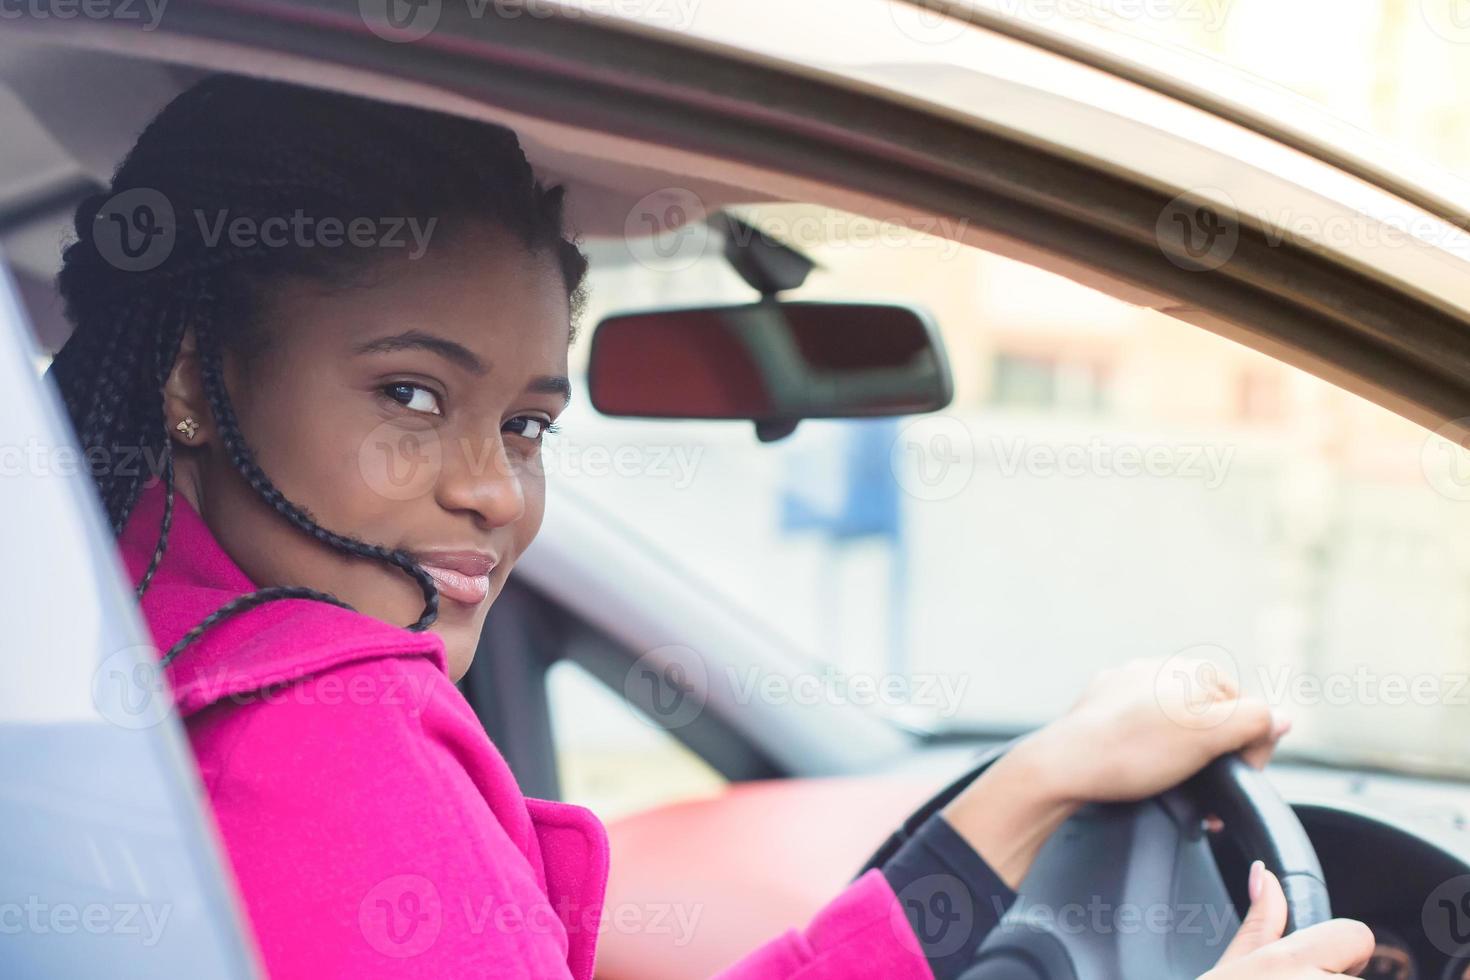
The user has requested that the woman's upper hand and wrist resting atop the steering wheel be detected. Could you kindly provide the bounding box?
[942,657,1289,887]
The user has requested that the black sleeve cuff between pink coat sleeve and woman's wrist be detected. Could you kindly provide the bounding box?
[882,814,1016,980]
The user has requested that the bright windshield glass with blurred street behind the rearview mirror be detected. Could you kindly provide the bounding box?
[558,206,1470,774]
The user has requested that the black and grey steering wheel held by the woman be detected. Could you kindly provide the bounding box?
[864,745,1332,980]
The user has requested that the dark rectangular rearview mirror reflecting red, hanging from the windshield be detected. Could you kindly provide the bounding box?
[588,300,954,435]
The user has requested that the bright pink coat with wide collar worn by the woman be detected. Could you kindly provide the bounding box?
[119,485,932,980]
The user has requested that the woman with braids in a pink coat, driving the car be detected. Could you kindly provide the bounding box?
[51,78,1372,980]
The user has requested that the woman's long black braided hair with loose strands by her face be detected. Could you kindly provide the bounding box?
[50,75,587,666]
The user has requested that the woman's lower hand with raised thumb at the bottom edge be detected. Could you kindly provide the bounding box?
[1200,861,1373,980]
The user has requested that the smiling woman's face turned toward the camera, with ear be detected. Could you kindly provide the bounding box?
[169,231,570,680]
